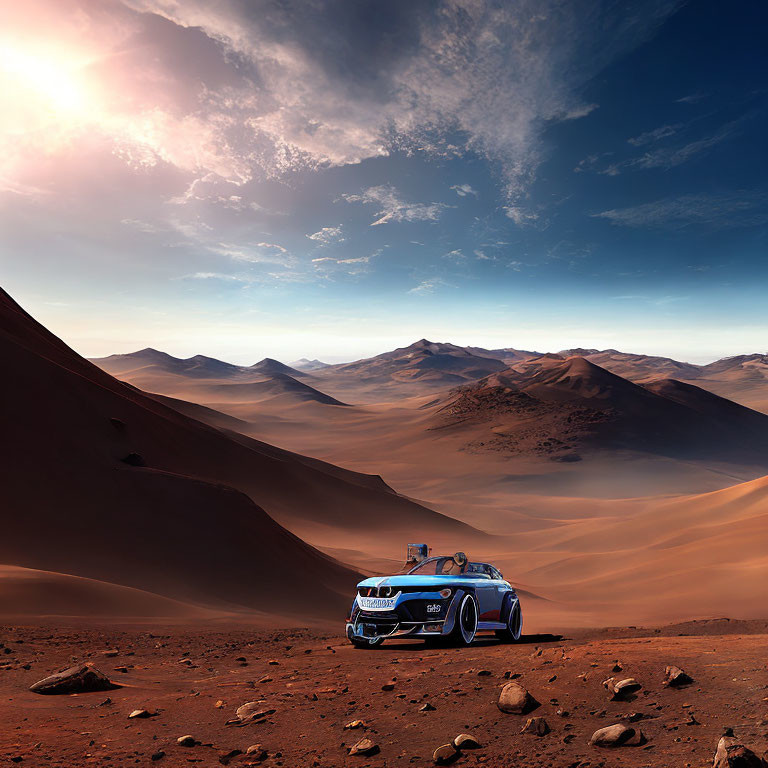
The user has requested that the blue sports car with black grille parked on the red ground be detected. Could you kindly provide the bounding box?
[346,544,523,648]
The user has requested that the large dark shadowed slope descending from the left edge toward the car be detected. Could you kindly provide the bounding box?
[0,292,472,615]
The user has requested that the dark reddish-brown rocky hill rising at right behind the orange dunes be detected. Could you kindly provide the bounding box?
[436,356,768,466]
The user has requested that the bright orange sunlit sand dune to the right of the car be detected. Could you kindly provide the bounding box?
[497,477,768,623]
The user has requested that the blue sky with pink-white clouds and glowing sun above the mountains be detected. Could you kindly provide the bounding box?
[0,0,768,363]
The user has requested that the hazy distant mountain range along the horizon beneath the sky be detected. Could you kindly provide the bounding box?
[92,339,768,411]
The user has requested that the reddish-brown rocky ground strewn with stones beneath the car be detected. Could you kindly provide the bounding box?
[0,620,768,768]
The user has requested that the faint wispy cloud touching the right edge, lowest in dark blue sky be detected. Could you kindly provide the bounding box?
[592,193,768,230]
